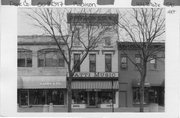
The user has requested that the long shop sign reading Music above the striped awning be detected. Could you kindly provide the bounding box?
[73,72,118,77]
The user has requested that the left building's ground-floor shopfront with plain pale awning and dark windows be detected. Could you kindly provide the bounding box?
[18,76,66,106]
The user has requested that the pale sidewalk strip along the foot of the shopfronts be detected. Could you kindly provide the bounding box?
[18,106,165,112]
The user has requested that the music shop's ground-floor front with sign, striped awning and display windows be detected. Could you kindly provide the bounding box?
[72,72,118,108]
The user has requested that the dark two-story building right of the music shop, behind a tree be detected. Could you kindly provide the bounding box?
[118,42,165,107]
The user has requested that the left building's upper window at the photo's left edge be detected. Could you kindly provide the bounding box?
[17,50,32,67]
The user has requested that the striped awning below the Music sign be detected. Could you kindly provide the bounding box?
[72,81,118,89]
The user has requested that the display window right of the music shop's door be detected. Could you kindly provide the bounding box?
[98,91,115,104]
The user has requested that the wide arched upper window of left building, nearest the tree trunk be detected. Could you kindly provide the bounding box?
[38,50,65,67]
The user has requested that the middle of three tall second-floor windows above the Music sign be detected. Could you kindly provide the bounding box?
[89,54,96,72]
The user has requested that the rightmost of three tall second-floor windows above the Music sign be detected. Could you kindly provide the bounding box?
[105,54,112,72]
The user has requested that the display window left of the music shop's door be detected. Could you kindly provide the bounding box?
[72,90,87,104]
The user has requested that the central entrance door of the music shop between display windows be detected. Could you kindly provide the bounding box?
[88,91,97,107]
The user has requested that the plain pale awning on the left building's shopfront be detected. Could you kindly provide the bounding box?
[18,76,66,89]
